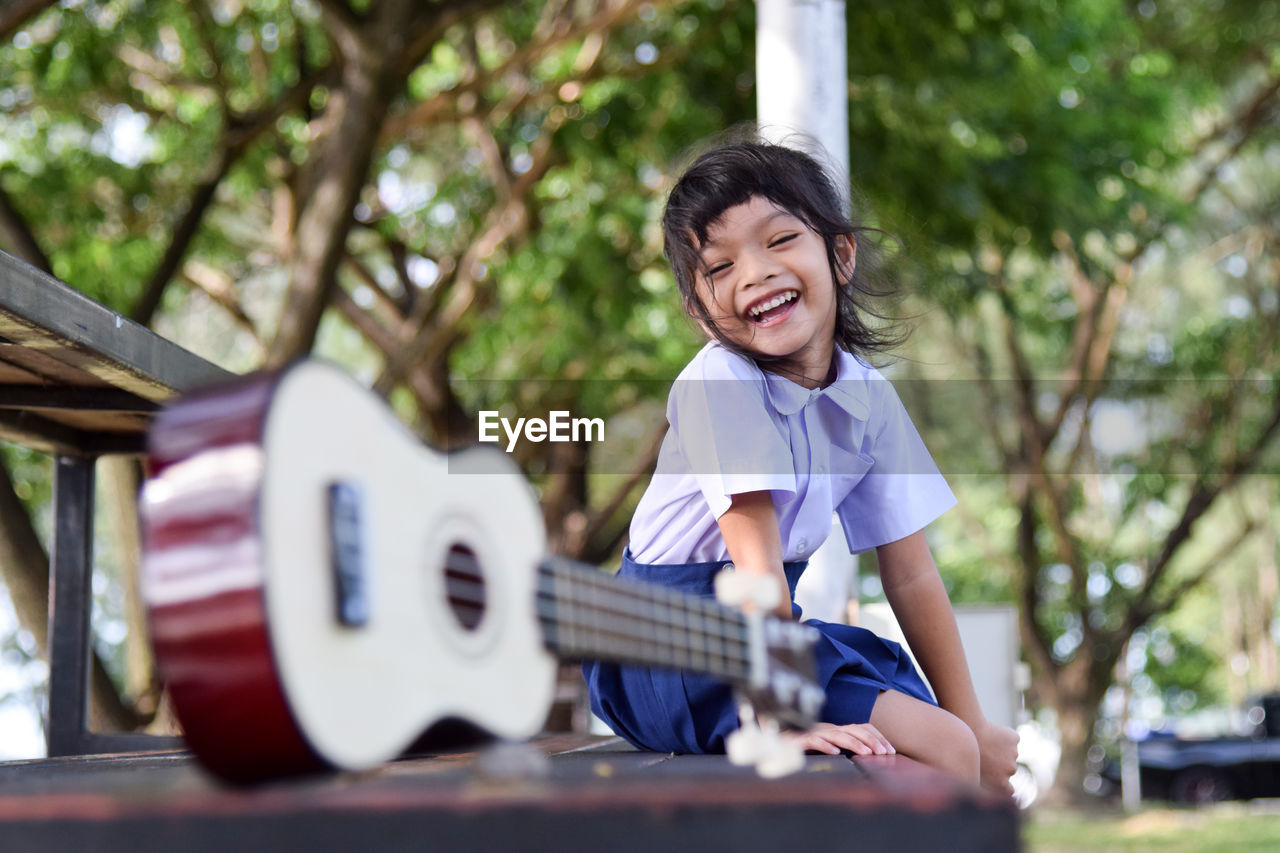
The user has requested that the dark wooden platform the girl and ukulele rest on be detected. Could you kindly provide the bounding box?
[0,735,1019,853]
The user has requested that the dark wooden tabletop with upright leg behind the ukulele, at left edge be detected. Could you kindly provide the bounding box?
[0,252,228,756]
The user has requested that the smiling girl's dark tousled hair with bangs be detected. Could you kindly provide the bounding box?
[662,140,906,366]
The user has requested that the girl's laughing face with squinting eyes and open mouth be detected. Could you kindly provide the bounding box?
[698,196,855,388]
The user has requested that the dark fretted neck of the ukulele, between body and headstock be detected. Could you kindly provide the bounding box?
[538,557,750,683]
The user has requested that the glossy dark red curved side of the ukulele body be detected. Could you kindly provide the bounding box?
[142,375,324,780]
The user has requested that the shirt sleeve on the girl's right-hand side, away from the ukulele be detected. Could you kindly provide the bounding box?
[836,374,956,553]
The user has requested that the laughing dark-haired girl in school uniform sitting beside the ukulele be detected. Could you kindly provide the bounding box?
[584,142,1018,793]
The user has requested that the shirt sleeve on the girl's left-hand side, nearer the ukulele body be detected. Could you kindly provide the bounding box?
[667,346,796,517]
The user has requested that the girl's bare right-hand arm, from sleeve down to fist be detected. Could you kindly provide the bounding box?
[876,530,1018,794]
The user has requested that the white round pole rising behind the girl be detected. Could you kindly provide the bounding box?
[755,0,858,621]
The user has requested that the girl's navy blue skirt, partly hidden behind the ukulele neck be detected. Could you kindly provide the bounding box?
[582,551,937,753]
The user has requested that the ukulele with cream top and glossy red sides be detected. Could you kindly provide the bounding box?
[141,361,824,781]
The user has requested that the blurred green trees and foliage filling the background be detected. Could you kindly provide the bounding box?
[0,0,1280,824]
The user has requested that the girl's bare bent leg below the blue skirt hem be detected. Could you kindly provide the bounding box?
[870,690,982,785]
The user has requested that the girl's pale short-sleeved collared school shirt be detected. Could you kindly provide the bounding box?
[630,341,956,564]
